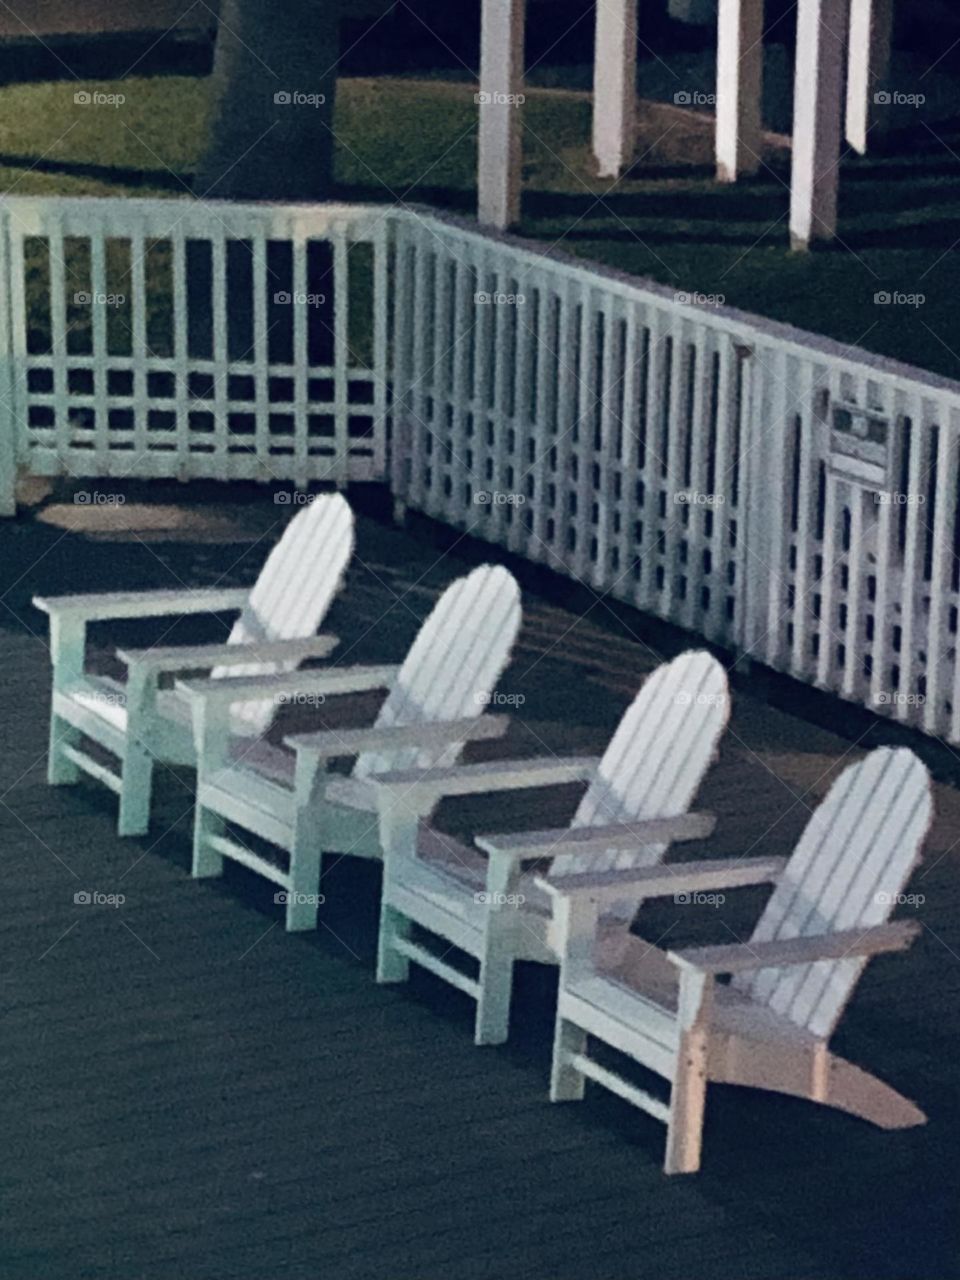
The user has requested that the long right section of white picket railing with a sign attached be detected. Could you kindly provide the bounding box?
[392,218,960,742]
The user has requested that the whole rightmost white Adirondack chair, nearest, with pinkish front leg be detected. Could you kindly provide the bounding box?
[543,748,933,1174]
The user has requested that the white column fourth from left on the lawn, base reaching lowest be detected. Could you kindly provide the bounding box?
[790,0,850,248]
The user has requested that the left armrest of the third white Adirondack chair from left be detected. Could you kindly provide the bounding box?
[367,755,600,808]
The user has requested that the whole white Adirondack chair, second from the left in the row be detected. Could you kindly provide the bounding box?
[178,564,521,931]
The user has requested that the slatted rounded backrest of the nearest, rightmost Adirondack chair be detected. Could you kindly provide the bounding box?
[733,748,933,1037]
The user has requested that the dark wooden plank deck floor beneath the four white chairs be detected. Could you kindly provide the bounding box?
[0,490,960,1280]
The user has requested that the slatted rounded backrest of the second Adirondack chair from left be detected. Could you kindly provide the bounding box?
[353,564,520,778]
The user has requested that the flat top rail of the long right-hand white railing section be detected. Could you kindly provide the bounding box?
[404,206,960,399]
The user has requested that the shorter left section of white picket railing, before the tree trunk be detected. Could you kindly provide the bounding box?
[0,197,388,499]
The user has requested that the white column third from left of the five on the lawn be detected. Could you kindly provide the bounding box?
[717,0,763,182]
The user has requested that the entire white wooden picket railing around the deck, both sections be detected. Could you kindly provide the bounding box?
[0,198,960,742]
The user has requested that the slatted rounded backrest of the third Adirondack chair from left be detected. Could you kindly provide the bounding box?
[550,650,730,880]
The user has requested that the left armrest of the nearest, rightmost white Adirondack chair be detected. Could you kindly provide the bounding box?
[538,855,787,902]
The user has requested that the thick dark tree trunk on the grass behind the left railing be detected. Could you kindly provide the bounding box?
[193,0,340,200]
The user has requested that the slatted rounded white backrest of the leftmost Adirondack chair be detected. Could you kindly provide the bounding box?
[211,493,353,736]
